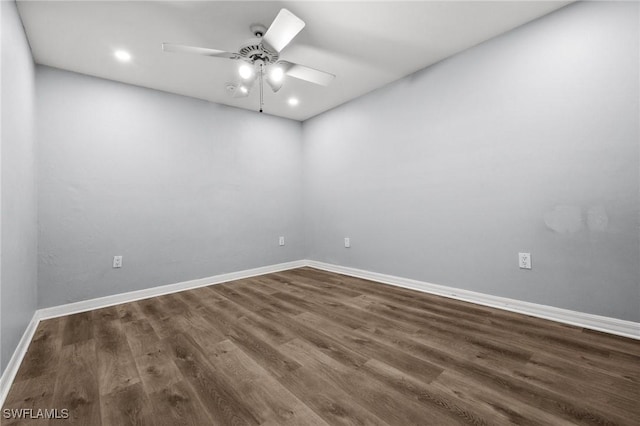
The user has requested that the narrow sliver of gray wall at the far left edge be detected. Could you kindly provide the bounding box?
[0,1,37,371]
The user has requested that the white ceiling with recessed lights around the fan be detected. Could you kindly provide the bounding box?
[18,1,570,120]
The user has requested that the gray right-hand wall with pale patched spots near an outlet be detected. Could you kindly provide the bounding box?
[303,2,640,321]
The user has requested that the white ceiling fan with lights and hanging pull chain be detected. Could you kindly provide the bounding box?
[162,9,335,112]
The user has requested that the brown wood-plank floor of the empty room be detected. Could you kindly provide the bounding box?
[2,268,640,426]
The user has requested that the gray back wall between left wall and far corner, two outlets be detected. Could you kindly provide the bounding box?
[37,66,304,307]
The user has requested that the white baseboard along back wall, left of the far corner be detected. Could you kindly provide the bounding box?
[39,260,306,319]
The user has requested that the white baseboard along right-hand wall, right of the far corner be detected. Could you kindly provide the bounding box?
[306,260,640,339]
